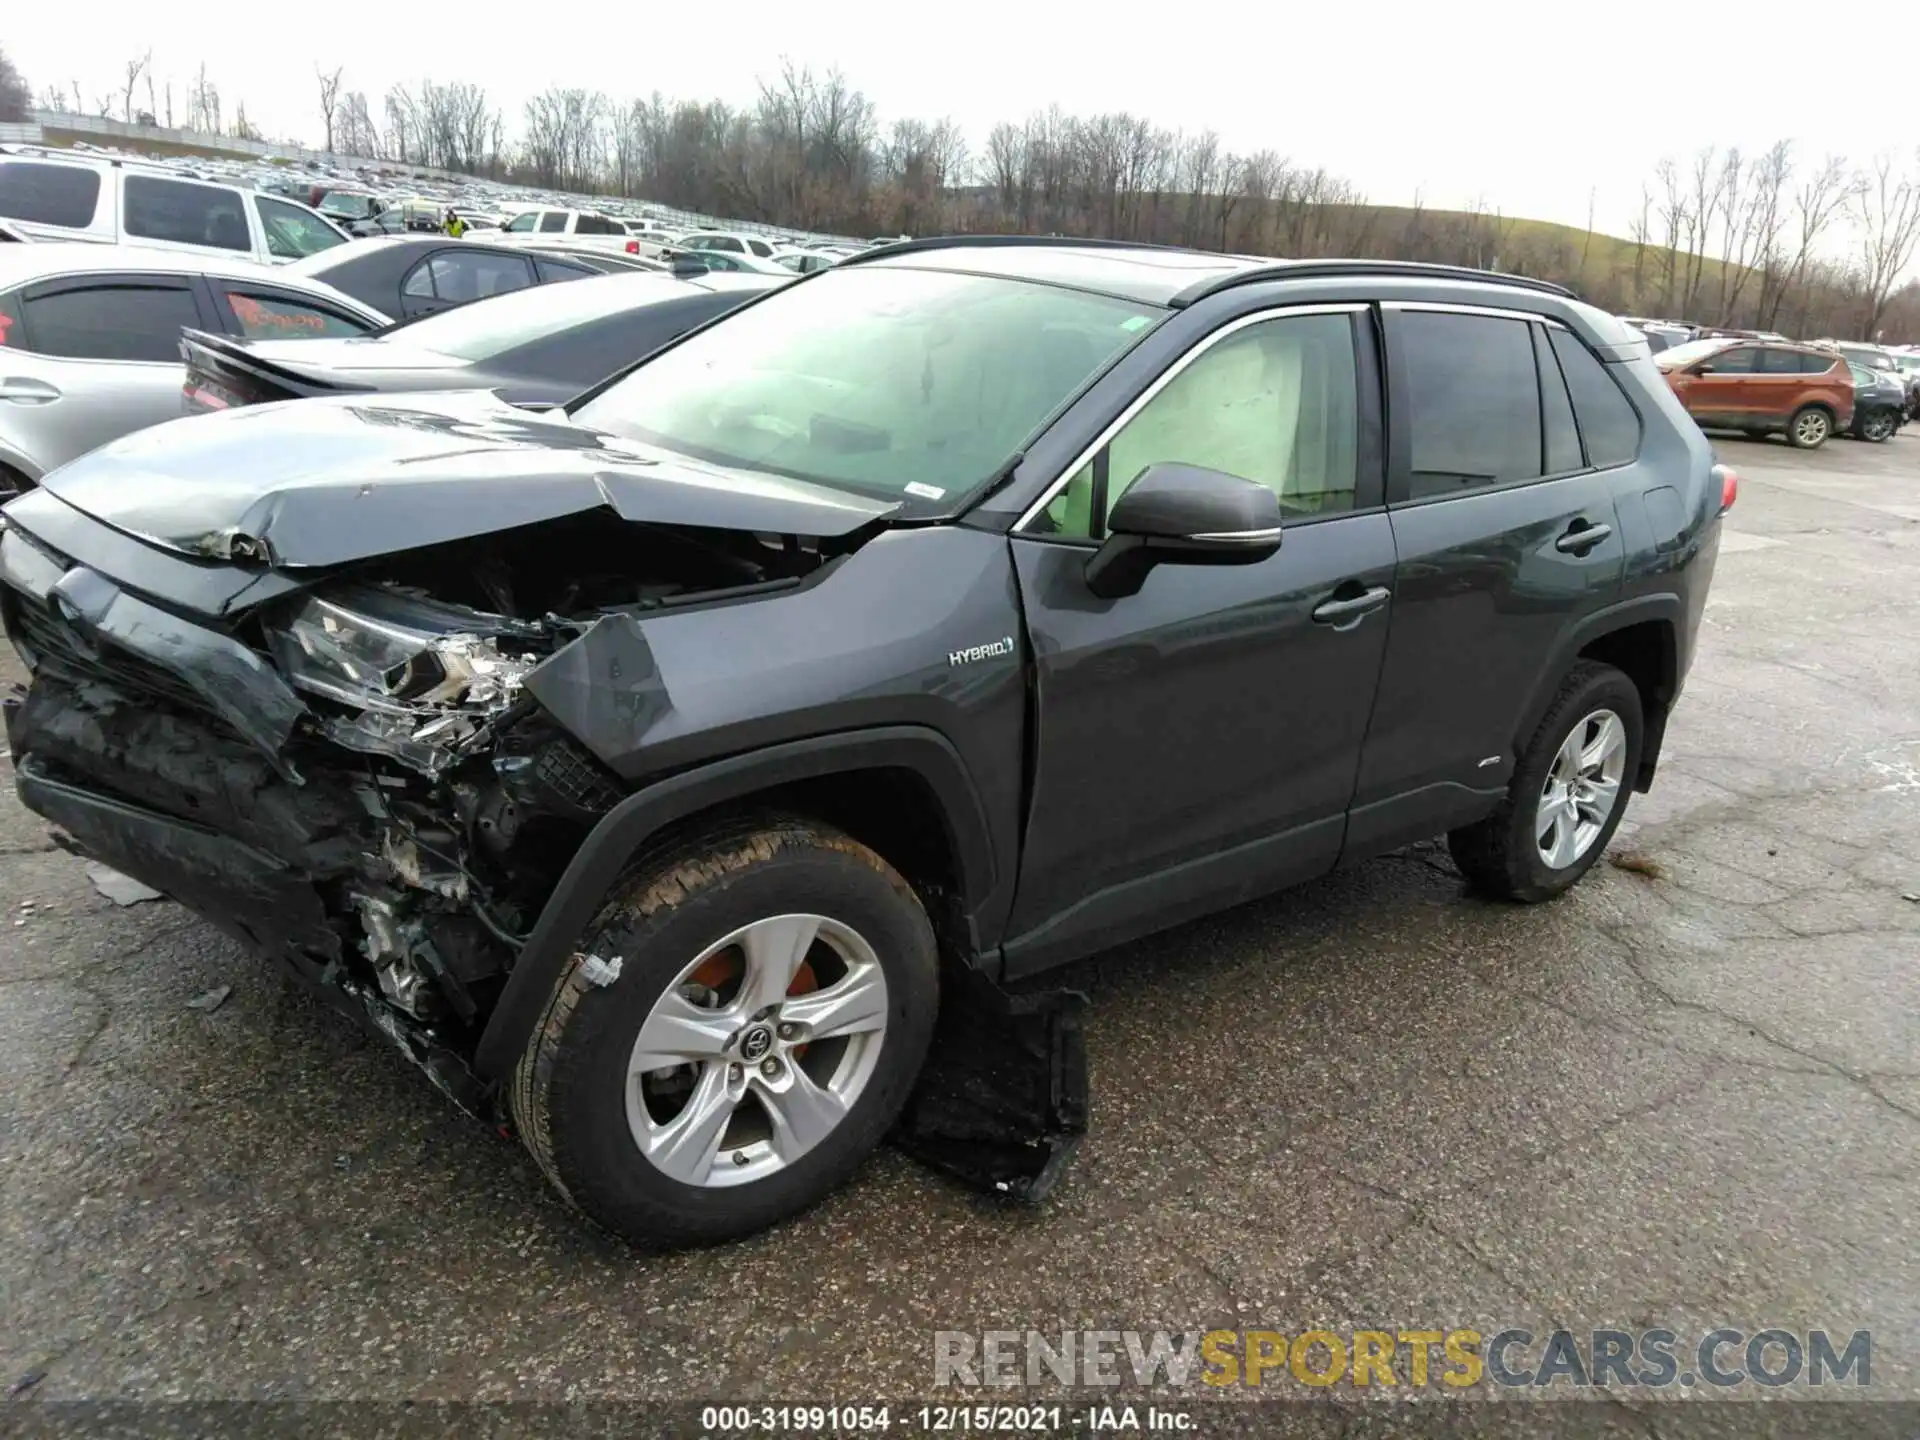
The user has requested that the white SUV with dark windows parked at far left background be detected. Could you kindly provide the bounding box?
[0,154,348,265]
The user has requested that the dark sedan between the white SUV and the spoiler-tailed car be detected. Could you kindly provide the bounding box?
[284,234,629,319]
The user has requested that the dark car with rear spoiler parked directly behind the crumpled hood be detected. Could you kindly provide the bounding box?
[182,275,785,413]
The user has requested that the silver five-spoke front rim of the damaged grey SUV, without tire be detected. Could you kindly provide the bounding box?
[626,914,887,1187]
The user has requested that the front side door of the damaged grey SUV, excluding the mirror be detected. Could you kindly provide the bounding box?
[1006,307,1394,975]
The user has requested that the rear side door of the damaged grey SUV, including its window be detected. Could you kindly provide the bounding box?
[1348,303,1638,854]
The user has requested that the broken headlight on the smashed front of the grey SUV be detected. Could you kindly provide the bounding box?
[267,586,538,714]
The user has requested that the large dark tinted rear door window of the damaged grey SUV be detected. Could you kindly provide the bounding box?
[1396,311,1542,499]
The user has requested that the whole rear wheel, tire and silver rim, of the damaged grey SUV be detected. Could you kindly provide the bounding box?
[1448,660,1644,904]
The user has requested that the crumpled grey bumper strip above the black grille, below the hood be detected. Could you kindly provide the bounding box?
[0,528,307,780]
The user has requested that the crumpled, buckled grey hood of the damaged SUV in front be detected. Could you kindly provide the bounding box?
[40,390,899,568]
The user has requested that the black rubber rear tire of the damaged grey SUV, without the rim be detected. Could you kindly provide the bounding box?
[1446,660,1645,904]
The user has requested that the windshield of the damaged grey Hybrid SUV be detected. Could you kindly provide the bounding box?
[574,265,1160,505]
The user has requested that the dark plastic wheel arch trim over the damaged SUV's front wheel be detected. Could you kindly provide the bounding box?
[474,726,998,1081]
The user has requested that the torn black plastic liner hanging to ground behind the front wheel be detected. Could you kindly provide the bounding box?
[893,966,1089,1202]
